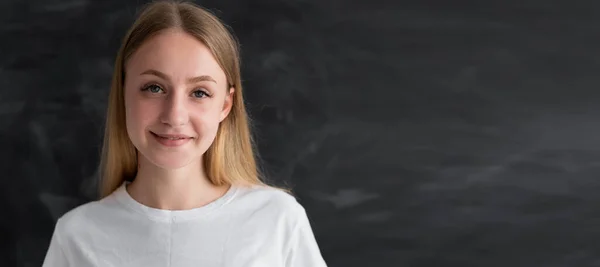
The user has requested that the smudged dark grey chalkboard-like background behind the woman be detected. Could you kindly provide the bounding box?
[0,0,600,267]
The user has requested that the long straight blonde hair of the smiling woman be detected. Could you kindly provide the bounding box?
[99,1,276,198]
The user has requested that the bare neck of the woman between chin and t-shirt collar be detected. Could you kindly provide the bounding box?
[127,157,229,210]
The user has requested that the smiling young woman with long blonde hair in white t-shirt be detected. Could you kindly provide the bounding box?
[43,1,326,267]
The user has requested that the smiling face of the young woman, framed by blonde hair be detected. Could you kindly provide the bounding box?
[124,30,233,169]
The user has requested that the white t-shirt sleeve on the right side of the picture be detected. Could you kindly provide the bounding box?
[285,208,327,267]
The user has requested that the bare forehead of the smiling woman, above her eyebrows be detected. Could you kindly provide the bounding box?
[125,30,226,84]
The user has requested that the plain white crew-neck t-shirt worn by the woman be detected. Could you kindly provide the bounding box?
[43,183,326,267]
